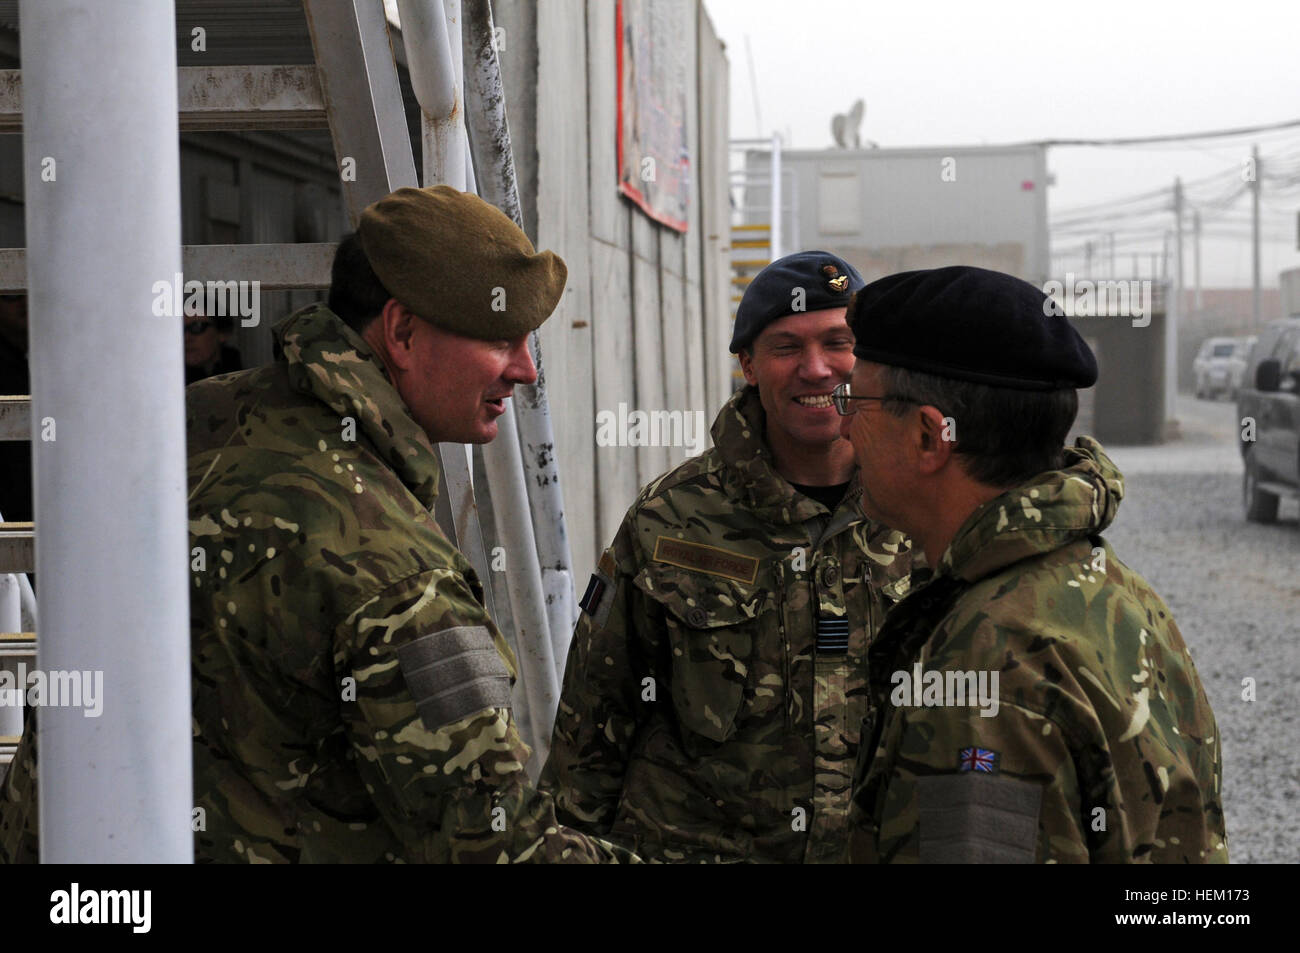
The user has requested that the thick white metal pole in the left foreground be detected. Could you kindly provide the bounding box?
[20,0,194,863]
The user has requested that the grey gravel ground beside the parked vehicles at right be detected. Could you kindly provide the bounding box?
[1106,398,1300,863]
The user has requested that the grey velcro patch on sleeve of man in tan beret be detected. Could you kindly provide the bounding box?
[398,625,510,731]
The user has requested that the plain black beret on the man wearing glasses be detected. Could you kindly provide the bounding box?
[848,265,1097,390]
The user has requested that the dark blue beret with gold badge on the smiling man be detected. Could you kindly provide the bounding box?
[731,251,866,354]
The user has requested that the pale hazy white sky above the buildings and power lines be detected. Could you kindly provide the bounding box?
[705,0,1300,287]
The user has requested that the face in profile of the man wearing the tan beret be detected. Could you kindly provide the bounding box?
[395,319,537,443]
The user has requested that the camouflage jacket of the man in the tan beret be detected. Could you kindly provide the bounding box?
[187,306,615,862]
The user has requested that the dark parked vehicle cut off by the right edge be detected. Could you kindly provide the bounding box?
[1236,317,1300,523]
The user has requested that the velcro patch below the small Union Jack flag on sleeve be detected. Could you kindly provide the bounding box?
[917,772,1043,863]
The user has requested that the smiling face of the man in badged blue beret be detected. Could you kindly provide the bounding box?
[740,308,853,449]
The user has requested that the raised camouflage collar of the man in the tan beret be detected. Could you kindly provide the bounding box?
[273,304,439,510]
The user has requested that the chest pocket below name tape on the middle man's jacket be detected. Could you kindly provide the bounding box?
[637,571,781,754]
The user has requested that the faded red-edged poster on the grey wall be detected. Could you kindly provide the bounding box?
[616,0,693,231]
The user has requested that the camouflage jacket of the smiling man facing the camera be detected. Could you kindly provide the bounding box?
[542,391,910,862]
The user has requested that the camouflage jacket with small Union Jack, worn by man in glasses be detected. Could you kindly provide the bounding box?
[852,437,1227,863]
